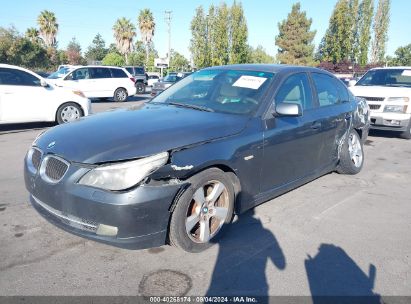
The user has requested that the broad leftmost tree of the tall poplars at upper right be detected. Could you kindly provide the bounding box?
[322,0,352,63]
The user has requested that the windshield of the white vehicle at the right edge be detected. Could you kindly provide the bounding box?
[356,69,411,87]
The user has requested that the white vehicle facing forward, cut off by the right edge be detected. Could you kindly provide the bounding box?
[350,67,411,139]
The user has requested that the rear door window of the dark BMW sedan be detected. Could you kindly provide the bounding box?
[311,73,340,107]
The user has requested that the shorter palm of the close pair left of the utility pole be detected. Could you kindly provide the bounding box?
[113,17,136,63]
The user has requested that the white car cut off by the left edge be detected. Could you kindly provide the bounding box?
[0,64,91,124]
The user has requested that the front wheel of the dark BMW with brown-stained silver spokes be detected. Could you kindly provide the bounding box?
[169,168,234,252]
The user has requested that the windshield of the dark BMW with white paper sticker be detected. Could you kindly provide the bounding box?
[152,69,274,114]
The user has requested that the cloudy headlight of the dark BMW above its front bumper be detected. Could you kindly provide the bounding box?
[79,152,168,190]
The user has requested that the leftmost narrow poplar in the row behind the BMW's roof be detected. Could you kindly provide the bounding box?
[190,6,210,69]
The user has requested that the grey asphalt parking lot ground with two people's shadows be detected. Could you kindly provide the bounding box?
[0,98,411,297]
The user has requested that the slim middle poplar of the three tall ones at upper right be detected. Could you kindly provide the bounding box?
[358,0,374,66]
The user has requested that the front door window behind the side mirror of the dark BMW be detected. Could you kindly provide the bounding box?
[275,73,313,110]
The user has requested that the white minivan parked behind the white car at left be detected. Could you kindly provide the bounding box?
[55,66,136,101]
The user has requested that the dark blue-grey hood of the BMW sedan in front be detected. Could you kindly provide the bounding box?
[35,103,249,164]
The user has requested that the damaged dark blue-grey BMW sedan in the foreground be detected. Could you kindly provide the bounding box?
[25,65,369,252]
